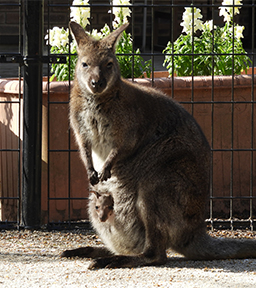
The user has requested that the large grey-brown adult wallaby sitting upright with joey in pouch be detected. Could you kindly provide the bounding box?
[62,22,256,268]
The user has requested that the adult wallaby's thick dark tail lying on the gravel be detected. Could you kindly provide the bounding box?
[183,234,256,260]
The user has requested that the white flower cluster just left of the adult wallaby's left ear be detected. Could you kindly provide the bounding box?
[45,27,69,48]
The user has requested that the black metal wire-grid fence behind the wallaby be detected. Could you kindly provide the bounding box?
[0,0,256,230]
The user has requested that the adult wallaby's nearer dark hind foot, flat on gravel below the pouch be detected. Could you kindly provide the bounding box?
[88,254,167,269]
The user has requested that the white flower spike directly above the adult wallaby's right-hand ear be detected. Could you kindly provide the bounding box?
[109,0,131,28]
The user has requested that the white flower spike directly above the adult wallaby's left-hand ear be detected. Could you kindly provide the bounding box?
[70,0,90,28]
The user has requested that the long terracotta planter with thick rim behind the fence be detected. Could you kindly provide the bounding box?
[0,74,256,223]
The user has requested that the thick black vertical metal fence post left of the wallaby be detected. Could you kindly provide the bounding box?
[21,0,44,229]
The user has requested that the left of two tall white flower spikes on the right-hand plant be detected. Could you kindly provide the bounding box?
[180,7,203,34]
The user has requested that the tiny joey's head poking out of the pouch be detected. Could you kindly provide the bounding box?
[90,191,114,222]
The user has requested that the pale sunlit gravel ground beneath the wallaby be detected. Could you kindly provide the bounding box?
[0,230,256,288]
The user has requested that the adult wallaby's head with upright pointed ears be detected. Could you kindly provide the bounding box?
[69,22,129,95]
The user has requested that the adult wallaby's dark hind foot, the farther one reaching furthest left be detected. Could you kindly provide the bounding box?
[60,246,113,258]
